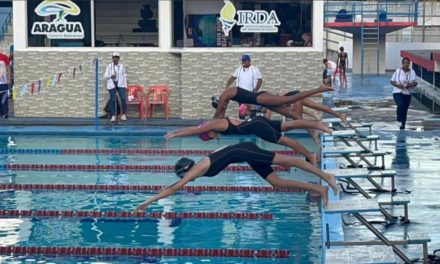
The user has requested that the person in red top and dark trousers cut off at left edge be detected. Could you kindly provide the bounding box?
[0,50,11,118]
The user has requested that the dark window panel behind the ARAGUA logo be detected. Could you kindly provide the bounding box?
[27,0,91,47]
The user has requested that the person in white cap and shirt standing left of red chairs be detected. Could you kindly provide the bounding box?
[104,52,127,123]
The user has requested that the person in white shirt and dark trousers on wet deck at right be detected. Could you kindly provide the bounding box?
[391,57,417,129]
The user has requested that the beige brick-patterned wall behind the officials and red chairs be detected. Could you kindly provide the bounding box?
[14,51,323,119]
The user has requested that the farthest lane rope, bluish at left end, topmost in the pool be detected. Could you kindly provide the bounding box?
[0,148,298,156]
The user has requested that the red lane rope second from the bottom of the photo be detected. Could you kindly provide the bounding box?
[0,210,273,221]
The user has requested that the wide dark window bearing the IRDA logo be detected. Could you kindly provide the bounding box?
[173,0,313,47]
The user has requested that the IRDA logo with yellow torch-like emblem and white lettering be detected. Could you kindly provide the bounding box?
[220,0,281,36]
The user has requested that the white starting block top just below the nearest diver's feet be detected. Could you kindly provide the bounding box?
[324,199,380,214]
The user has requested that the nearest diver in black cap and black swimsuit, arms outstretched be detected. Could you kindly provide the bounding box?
[135,142,338,212]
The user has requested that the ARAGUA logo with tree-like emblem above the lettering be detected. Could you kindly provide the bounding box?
[31,0,84,39]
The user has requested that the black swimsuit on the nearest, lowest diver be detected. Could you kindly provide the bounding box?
[204,142,275,179]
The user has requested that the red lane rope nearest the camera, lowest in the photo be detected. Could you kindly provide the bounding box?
[0,246,290,258]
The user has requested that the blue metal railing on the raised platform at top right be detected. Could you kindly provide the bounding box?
[324,0,419,23]
